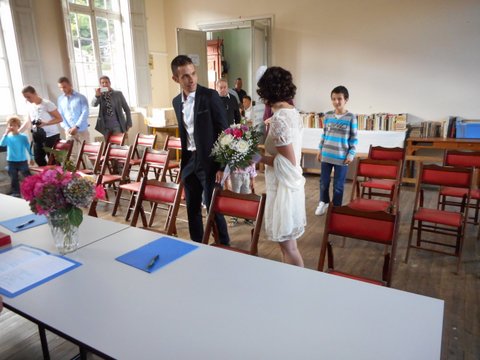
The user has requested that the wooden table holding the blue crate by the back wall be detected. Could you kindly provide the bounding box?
[403,137,480,183]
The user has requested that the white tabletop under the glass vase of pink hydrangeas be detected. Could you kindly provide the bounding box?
[0,194,129,253]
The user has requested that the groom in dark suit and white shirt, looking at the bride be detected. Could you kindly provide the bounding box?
[171,55,230,245]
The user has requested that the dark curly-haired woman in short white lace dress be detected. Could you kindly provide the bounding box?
[257,67,306,266]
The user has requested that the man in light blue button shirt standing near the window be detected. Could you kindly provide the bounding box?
[57,76,90,159]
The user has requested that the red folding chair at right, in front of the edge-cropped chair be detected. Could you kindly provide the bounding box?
[405,164,473,273]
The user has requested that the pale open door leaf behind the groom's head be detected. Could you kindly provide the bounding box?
[177,28,208,87]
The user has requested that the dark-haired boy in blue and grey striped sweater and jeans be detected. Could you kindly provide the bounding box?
[315,86,358,215]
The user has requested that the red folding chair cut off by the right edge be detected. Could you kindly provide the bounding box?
[438,150,480,225]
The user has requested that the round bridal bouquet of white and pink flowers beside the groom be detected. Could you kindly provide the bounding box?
[212,124,261,170]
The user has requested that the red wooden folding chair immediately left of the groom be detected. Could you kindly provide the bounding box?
[130,177,182,235]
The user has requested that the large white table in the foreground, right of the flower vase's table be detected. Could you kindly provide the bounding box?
[5,228,444,360]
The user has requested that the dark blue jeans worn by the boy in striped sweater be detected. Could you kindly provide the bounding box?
[320,161,348,206]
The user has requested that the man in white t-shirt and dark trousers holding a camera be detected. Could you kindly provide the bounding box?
[20,85,62,166]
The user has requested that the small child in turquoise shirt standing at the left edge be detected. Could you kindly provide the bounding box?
[0,116,34,197]
